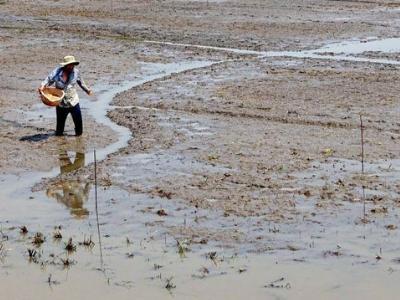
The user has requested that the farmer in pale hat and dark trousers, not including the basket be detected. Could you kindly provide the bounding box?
[39,55,93,136]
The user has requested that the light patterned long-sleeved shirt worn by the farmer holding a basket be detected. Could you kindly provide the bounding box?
[42,67,90,107]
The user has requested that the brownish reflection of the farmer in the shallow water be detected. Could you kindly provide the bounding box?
[46,151,90,218]
